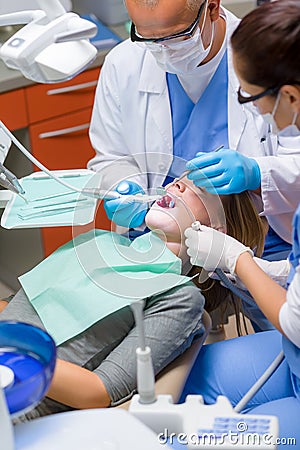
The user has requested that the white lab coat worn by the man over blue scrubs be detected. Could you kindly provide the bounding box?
[88,9,300,242]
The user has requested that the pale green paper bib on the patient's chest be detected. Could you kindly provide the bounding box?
[19,230,190,345]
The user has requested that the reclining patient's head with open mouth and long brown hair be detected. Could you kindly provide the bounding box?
[146,178,268,324]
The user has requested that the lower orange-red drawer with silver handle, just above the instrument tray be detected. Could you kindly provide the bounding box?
[29,108,95,170]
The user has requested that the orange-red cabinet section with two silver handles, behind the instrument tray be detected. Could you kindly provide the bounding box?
[25,69,111,256]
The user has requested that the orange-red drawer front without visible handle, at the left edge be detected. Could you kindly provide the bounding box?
[0,89,28,130]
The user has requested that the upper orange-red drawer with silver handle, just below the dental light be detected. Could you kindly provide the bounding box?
[25,68,100,123]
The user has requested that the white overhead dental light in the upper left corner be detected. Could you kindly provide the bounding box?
[0,0,97,83]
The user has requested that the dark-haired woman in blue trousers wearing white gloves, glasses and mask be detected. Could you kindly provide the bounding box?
[183,0,300,449]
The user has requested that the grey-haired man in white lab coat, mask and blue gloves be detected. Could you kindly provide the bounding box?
[88,0,300,256]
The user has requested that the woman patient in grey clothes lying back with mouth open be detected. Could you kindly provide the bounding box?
[0,178,265,419]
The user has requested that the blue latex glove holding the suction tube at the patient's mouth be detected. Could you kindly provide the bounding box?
[104,180,148,228]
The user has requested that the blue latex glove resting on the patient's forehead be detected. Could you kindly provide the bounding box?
[186,148,261,195]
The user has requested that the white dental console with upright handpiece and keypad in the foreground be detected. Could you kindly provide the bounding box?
[129,301,281,450]
